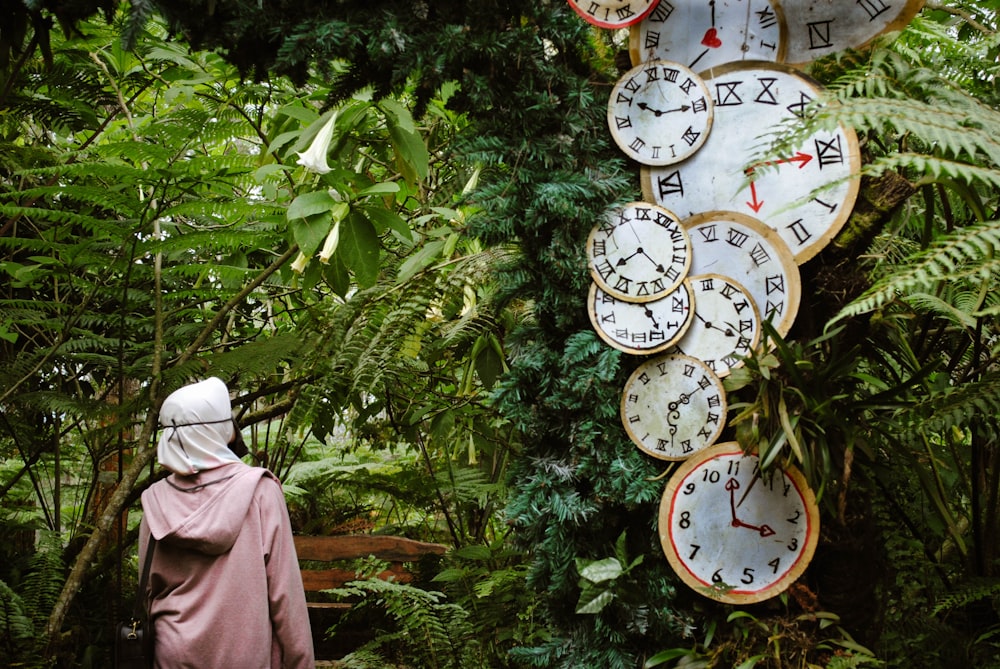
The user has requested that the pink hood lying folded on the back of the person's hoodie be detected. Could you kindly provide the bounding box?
[142,462,277,555]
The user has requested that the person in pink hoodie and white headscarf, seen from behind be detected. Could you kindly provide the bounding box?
[139,378,315,669]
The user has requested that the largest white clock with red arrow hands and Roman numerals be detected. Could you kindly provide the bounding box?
[642,61,861,264]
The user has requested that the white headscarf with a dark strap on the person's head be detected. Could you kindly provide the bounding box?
[156,377,240,476]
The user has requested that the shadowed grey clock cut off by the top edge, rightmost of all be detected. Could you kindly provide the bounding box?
[781,0,924,66]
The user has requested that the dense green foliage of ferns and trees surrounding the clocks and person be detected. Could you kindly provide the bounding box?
[0,0,1000,668]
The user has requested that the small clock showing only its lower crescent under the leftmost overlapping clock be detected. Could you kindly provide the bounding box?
[587,281,694,355]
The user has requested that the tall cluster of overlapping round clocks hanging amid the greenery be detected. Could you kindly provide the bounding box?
[568,0,923,604]
